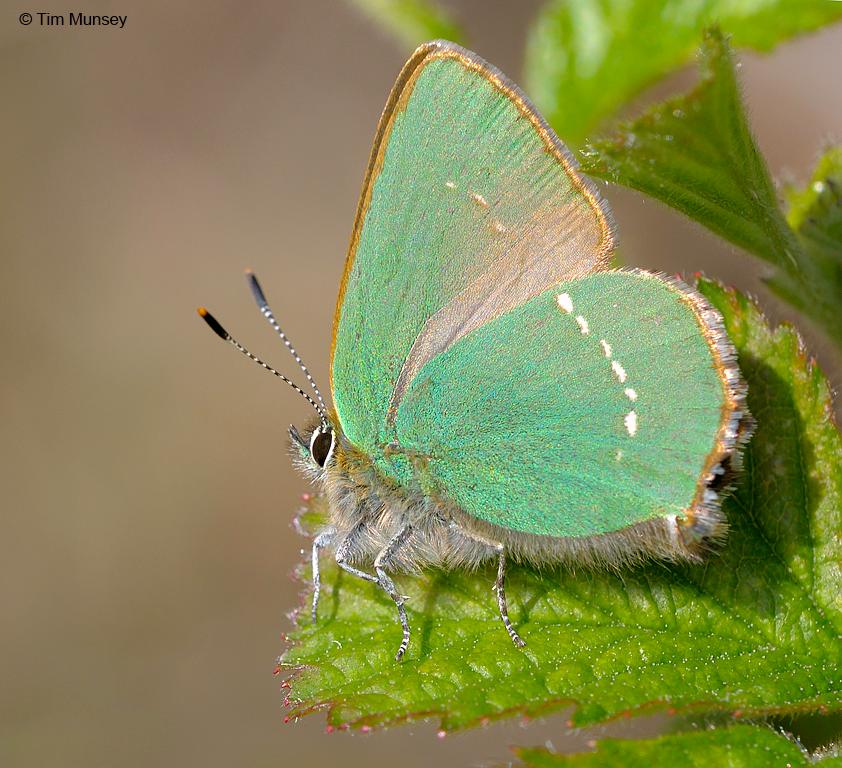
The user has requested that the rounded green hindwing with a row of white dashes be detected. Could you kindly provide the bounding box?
[391,271,727,536]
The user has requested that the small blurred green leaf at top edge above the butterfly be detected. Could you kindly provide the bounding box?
[352,0,464,50]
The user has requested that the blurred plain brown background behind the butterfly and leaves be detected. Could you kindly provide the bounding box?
[0,0,842,768]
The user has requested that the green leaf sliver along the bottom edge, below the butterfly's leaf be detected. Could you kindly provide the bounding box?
[516,725,842,768]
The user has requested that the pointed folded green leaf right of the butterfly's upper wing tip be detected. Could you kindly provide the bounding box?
[581,30,842,345]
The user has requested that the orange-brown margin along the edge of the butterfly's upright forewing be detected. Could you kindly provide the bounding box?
[330,40,615,400]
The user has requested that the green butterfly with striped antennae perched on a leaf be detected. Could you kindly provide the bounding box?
[199,41,751,659]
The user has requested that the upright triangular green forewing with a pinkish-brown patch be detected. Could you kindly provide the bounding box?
[331,43,612,468]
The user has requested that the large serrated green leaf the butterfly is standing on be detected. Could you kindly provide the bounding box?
[279,282,842,729]
